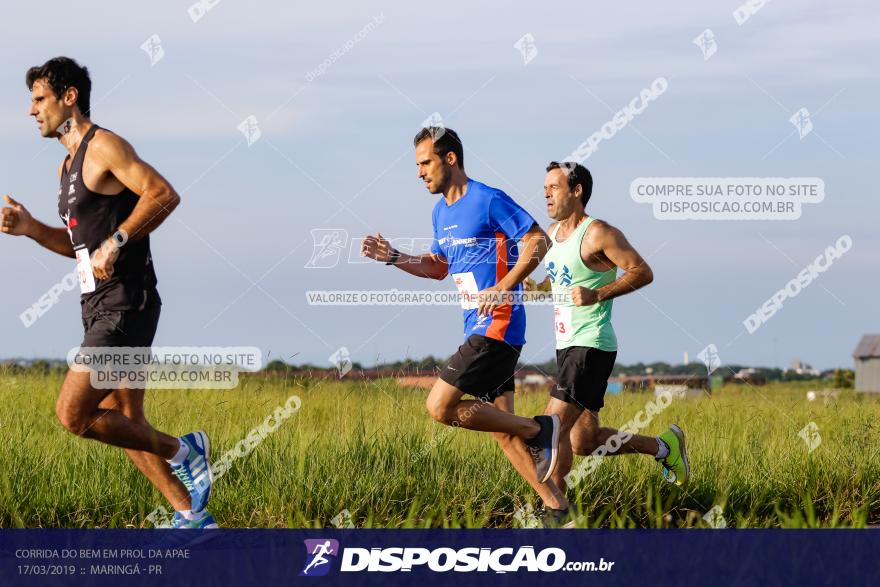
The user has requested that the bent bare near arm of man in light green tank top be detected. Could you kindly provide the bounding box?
[572,222,654,306]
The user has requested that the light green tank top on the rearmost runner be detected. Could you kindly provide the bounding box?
[544,216,617,351]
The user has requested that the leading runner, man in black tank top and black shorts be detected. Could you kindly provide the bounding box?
[0,57,216,528]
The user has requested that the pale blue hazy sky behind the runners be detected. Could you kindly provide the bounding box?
[0,0,880,368]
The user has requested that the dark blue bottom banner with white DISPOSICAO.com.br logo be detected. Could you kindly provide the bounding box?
[0,529,880,587]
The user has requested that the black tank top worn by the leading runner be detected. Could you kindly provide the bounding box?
[58,124,161,312]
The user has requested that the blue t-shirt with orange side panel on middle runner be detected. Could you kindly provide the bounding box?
[431,179,535,345]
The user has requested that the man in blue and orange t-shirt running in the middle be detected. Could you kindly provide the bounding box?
[361,127,564,507]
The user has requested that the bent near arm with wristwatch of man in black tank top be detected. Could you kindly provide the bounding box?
[88,132,180,241]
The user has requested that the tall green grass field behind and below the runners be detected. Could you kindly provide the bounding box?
[0,376,880,528]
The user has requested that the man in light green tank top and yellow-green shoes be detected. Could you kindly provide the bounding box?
[528,161,690,525]
